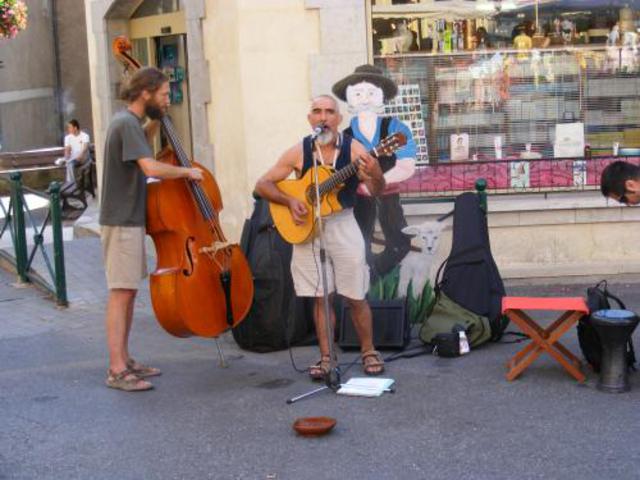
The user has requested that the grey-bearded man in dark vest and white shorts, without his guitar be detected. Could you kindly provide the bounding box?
[255,95,384,380]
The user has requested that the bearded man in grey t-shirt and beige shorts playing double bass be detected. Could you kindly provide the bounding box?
[100,67,203,391]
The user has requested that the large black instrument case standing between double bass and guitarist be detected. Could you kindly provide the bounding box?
[232,198,315,353]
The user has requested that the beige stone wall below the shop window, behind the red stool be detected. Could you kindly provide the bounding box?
[404,191,640,281]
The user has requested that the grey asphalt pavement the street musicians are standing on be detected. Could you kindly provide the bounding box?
[0,207,640,480]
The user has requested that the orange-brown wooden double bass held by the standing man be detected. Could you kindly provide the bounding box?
[113,37,253,337]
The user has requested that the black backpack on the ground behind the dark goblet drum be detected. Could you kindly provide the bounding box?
[578,280,636,373]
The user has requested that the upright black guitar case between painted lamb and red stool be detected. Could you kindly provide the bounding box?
[436,192,509,341]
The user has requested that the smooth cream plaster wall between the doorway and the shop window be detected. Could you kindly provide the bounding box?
[203,0,319,238]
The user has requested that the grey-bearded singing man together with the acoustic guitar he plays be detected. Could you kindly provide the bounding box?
[255,95,402,379]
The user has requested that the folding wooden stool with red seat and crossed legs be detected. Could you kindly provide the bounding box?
[502,297,589,382]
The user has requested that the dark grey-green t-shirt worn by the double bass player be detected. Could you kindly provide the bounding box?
[100,109,153,227]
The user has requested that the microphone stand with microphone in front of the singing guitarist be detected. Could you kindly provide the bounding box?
[287,127,340,404]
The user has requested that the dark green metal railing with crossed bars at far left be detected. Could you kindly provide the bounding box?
[0,172,69,307]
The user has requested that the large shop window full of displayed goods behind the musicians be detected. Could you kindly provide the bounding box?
[369,0,640,163]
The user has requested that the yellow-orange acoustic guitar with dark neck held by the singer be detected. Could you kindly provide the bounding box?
[269,133,407,244]
